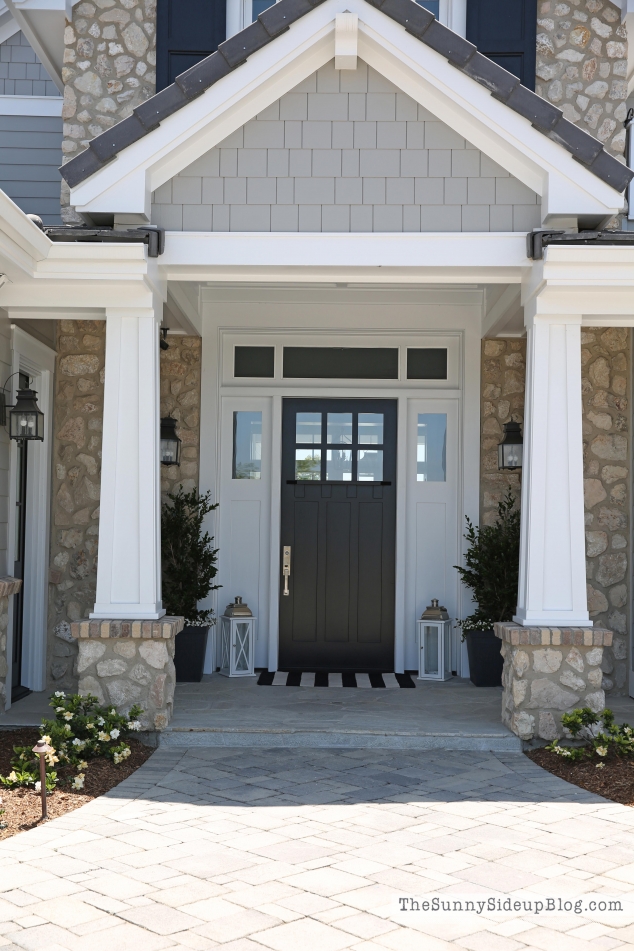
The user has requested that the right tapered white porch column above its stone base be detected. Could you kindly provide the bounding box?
[513,314,592,627]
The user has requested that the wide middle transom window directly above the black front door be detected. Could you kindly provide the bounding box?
[284,347,398,380]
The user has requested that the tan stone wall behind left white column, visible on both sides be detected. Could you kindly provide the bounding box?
[48,320,201,690]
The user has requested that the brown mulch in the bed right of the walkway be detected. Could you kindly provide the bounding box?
[526,749,634,806]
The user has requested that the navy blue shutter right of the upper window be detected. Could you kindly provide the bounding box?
[467,0,537,89]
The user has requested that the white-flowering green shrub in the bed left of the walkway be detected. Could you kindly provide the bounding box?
[0,690,143,790]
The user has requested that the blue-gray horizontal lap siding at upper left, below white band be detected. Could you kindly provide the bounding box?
[0,115,62,225]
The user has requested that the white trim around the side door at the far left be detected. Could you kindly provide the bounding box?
[6,325,55,709]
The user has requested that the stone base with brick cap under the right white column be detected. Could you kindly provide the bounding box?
[494,622,612,740]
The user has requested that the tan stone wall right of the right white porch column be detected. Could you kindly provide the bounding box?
[581,327,631,694]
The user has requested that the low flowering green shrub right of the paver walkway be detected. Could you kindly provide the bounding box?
[546,707,634,769]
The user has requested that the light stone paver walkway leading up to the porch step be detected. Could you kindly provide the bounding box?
[0,749,634,951]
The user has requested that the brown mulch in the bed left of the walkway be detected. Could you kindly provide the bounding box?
[0,728,154,839]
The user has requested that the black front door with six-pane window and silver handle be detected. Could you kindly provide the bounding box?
[279,399,397,672]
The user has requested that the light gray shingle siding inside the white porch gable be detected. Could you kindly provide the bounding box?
[152,61,541,232]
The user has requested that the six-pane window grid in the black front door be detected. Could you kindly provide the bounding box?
[295,413,384,482]
